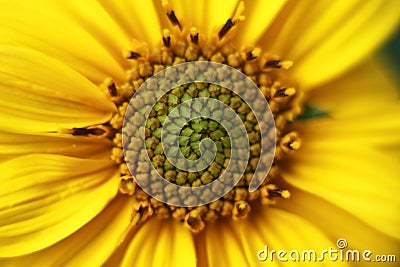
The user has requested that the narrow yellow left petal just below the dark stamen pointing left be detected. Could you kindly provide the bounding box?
[0,131,112,163]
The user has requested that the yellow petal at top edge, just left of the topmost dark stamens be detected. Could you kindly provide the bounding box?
[100,0,162,48]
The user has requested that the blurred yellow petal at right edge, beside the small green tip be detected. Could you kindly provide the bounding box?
[298,60,400,148]
